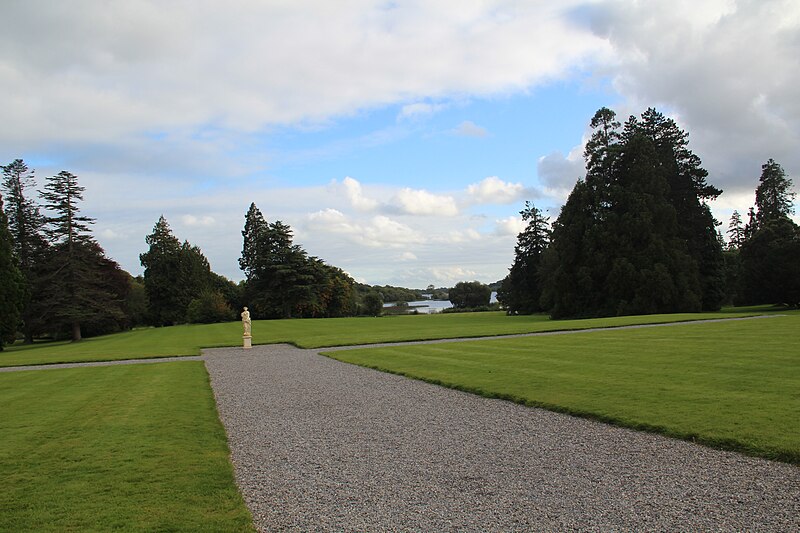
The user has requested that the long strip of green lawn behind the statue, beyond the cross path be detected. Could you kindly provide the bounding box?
[0,308,776,367]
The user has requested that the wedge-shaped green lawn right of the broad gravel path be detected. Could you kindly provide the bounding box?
[327,312,800,464]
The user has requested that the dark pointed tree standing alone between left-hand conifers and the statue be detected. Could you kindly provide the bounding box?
[139,215,212,326]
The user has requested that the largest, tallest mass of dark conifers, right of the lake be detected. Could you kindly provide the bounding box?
[539,108,724,318]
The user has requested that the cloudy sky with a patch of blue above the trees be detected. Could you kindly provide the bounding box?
[0,0,800,288]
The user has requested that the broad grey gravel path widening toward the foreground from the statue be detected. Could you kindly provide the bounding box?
[204,345,800,531]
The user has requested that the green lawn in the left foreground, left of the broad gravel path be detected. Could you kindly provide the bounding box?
[0,361,253,531]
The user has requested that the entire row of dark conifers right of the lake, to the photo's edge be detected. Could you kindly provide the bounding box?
[498,108,800,318]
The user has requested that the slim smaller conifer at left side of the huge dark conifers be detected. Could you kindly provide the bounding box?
[497,202,550,314]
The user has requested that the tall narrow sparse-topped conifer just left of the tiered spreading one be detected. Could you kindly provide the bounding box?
[2,159,48,344]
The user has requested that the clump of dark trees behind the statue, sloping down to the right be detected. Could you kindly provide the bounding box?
[239,203,356,318]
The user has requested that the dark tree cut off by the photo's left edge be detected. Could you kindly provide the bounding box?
[0,195,24,351]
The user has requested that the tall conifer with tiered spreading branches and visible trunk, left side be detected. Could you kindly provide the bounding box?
[41,171,124,341]
